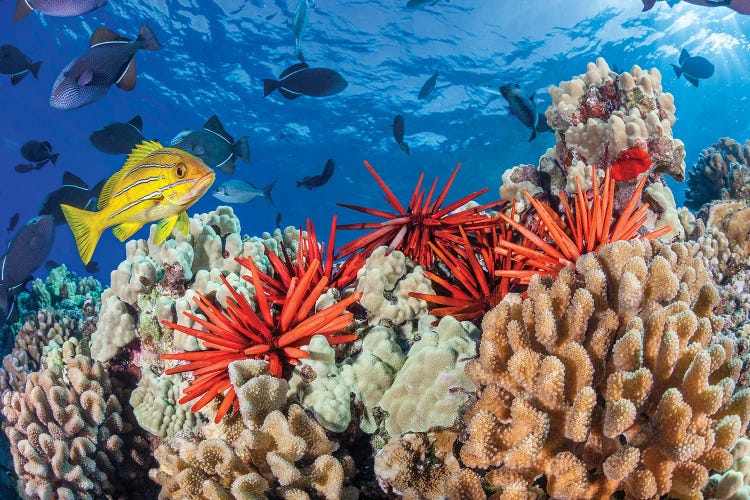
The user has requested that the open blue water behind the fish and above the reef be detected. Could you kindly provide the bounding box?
[0,0,750,282]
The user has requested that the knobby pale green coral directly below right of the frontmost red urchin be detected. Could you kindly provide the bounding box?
[289,326,406,433]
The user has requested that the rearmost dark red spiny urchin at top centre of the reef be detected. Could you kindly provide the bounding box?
[338,162,496,267]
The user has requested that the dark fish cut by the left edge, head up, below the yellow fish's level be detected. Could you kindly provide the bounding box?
[0,215,55,327]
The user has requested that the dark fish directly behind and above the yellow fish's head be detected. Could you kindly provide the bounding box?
[170,115,250,175]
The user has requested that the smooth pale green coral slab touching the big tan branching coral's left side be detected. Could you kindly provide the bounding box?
[380,316,479,436]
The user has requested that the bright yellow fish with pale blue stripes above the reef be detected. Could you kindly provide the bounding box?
[60,141,216,264]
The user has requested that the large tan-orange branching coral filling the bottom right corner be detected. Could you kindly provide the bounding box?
[460,240,750,498]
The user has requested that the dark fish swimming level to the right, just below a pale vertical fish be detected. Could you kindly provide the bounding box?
[263,62,349,99]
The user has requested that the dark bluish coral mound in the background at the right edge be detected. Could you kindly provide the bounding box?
[685,137,750,210]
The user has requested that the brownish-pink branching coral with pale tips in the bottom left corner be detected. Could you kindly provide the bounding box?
[2,356,150,499]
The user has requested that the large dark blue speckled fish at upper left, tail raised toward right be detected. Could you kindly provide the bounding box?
[49,23,161,109]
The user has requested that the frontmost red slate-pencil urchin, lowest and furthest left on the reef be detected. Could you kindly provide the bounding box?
[161,254,361,422]
